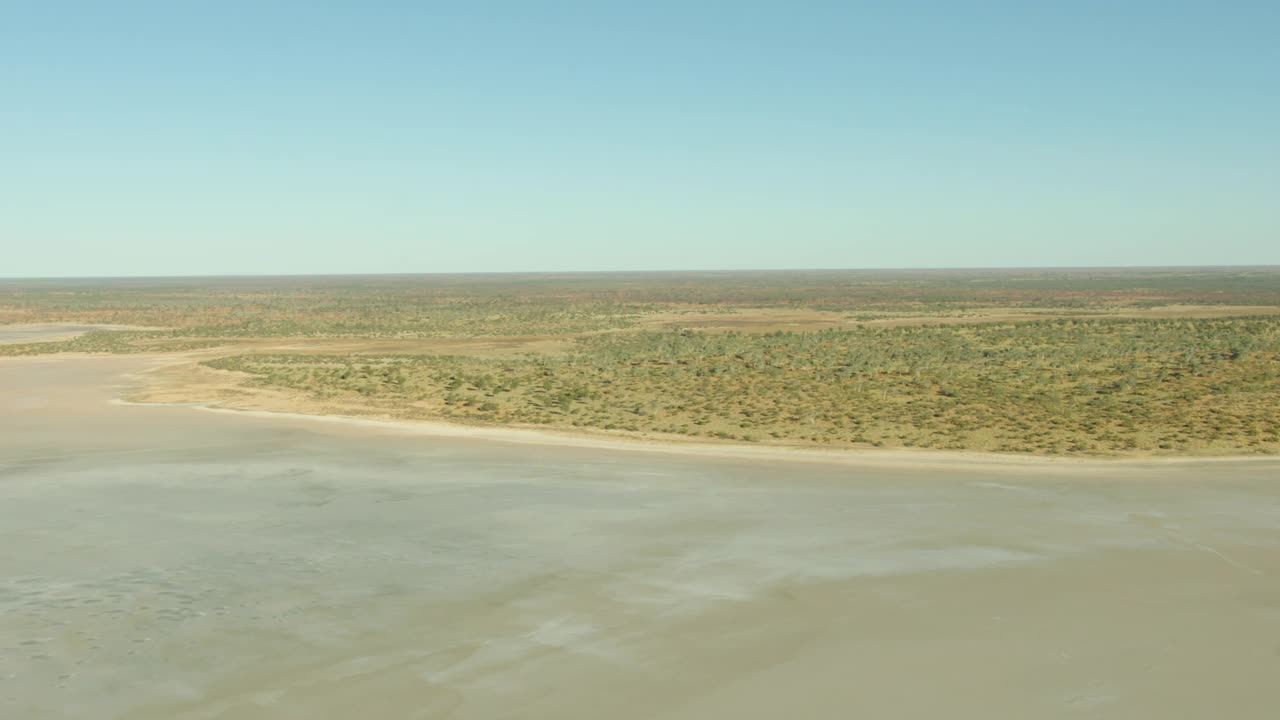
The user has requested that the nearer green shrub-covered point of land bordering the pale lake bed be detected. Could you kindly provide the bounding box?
[199,318,1280,454]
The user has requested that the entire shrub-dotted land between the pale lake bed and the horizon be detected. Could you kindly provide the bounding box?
[0,268,1280,456]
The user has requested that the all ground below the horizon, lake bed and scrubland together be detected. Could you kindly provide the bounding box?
[0,269,1280,720]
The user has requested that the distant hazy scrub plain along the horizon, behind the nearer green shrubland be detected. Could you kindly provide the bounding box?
[0,268,1280,337]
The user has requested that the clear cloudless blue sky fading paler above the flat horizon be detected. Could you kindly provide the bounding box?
[0,0,1280,277]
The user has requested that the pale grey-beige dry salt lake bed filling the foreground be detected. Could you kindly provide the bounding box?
[0,327,1280,719]
